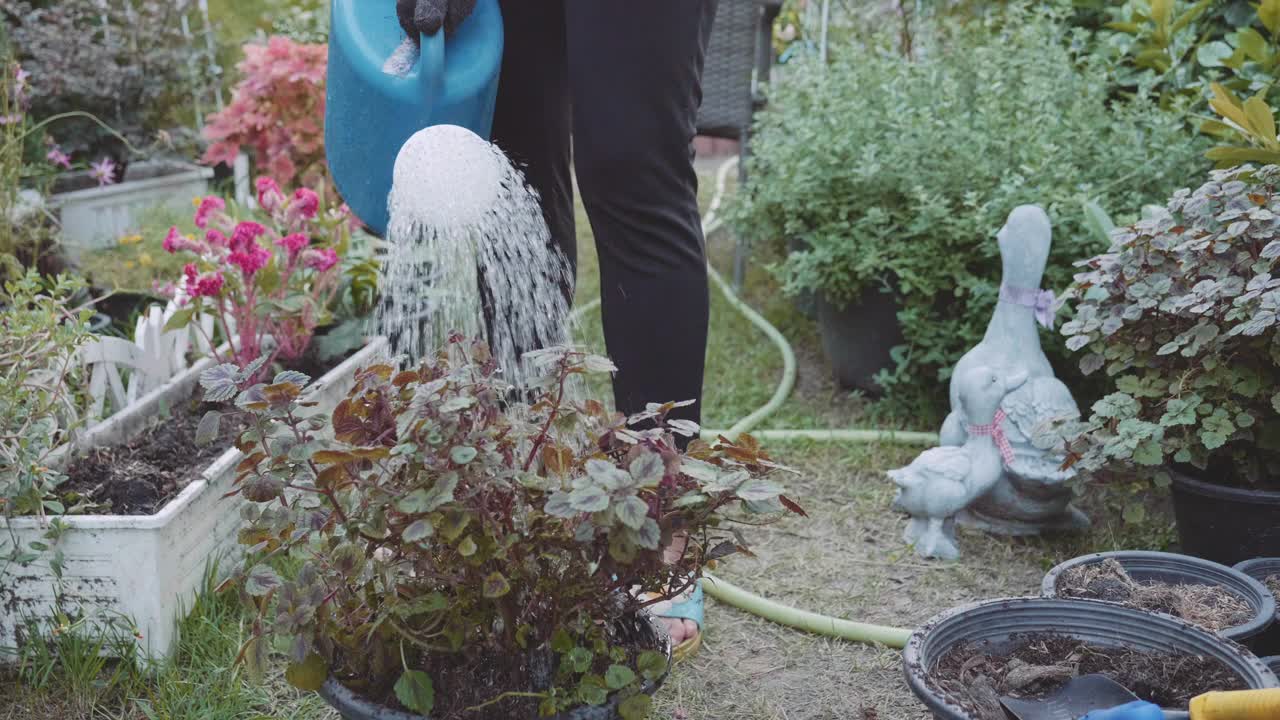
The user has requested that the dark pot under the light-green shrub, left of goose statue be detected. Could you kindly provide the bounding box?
[817,286,905,396]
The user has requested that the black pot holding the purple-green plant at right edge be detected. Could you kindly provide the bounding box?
[1171,473,1280,565]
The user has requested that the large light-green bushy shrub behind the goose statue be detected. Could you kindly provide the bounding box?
[731,5,1206,419]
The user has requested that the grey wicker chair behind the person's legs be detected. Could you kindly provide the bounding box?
[698,0,782,287]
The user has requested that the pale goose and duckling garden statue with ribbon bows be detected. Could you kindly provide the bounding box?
[890,205,1089,559]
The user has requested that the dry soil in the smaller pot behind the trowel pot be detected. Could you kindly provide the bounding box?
[1057,559,1254,632]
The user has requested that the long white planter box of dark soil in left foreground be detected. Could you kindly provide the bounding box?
[0,338,387,664]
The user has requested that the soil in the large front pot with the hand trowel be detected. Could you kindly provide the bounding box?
[929,633,1247,720]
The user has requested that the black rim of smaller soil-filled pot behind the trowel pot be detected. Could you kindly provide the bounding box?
[1041,550,1276,643]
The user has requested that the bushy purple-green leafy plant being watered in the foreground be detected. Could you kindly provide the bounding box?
[201,337,803,720]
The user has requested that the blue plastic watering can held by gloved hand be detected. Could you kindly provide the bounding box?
[325,0,503,236]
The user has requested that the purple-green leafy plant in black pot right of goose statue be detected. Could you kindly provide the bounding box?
[1062,165,1280,565]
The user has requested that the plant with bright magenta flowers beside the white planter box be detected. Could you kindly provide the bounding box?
[164,178,353,365]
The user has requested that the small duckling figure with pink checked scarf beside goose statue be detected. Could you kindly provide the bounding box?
[888,366,1027,560]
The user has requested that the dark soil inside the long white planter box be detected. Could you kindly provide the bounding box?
[59,389,243,515]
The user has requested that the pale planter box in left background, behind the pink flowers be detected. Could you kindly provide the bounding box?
[49,161,214,252]
